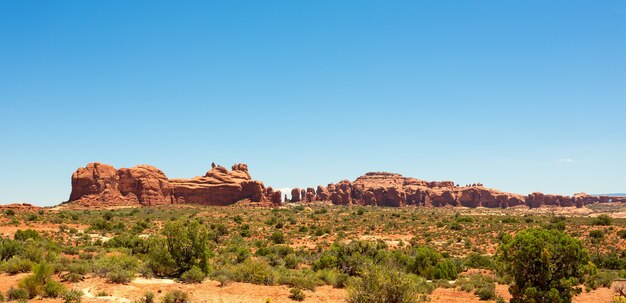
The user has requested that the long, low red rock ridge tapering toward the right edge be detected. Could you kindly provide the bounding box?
[306,172,626,208]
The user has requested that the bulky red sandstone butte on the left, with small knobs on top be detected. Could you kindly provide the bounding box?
[69,163,281,205]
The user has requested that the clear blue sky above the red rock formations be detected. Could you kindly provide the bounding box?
[0,0,626,205]
